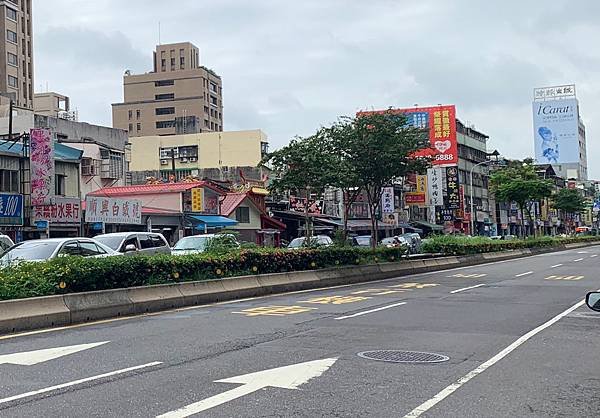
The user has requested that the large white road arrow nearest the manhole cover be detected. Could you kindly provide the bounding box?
[157,358,337,418]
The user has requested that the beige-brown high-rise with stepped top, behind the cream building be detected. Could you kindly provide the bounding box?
[112,42,223,137]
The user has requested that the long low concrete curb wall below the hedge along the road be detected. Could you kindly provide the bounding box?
[0,243,598,334]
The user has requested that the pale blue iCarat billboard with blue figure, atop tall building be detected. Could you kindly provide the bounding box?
[533,99,580,164]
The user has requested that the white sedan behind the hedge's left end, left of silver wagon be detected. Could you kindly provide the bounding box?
[0,238,118,266]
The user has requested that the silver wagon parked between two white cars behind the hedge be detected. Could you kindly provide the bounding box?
[94,232,171,255]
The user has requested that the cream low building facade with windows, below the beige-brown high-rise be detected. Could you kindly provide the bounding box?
[129,129,269,183]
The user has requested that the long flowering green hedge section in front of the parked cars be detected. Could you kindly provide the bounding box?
[0,247,404,300]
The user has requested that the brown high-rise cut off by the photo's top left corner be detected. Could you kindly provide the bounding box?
[0,0,33,109]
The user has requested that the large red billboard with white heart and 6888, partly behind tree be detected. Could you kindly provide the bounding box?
[358,105,458,166]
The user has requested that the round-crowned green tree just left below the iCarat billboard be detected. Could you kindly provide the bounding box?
[490,160,554,237]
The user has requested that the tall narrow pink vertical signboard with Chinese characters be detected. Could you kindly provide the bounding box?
[29,129,54,206]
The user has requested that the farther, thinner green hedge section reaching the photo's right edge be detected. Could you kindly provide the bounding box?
[422,235,600,255]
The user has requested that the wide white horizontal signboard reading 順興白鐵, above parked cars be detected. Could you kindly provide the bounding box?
[85,197,142,225]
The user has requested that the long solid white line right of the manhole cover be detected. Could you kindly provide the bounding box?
[404,300,585,418]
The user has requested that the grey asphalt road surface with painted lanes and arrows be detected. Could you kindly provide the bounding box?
[0,247,600,417]
